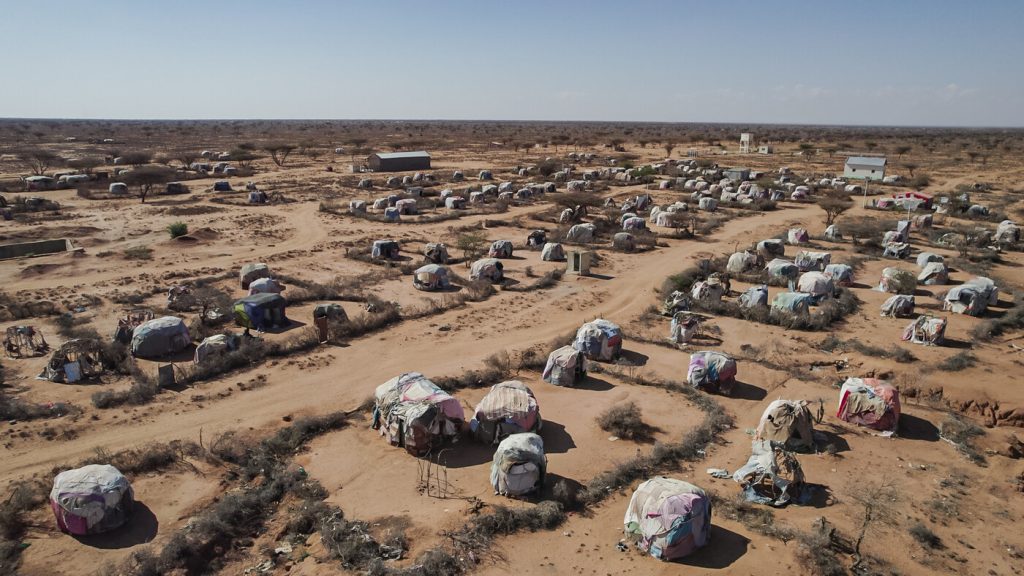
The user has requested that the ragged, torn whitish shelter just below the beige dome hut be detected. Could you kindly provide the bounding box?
[732,440,804,507]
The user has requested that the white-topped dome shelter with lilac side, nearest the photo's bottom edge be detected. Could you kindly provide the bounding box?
[623,476,711,561]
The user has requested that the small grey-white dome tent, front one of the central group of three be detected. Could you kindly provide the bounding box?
[490,433,548,497]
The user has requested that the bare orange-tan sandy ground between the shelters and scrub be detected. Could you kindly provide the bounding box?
[0,140,1024,575]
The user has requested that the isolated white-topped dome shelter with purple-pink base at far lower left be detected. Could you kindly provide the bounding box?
[50,464,135,536]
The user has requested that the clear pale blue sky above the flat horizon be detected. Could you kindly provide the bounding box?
[0,0,1024,126]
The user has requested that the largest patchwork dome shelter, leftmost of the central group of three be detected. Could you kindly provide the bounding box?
[373,372,466,456]
